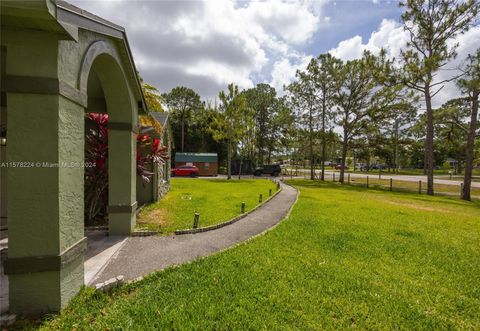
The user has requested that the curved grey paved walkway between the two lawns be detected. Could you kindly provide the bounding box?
[90,184,297,284]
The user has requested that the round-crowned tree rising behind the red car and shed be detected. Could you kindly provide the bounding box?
[162,86,204,152]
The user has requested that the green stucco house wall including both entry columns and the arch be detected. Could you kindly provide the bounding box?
[1,0,138,315]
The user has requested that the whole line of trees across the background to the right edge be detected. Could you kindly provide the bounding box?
[144,0,480,200]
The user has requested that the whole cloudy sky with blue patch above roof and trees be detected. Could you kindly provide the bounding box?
[70,0,480,104]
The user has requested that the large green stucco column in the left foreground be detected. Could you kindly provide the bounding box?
[2,31,86,315]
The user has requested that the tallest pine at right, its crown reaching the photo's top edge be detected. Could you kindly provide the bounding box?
[400,0,480,195]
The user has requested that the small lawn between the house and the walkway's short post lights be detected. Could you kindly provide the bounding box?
[137,178,276,234]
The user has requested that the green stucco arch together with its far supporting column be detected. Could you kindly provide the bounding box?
[79,41,137,235]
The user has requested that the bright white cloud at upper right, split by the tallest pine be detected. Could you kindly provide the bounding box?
[329,19,480,107]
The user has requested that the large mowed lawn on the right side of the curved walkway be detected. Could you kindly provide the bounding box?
[28,180,480,330]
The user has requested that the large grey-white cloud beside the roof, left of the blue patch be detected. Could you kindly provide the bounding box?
[68,0,328,98]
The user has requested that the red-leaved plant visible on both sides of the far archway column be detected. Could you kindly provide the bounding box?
[85,113,169,225]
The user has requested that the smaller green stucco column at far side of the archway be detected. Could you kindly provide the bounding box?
[108,127,137,235]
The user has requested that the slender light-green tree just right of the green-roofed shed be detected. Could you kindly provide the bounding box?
[211,84,247,179]
